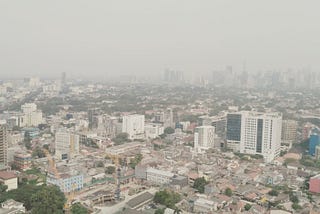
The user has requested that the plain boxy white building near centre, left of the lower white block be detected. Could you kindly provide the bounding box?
[122,114,144,140]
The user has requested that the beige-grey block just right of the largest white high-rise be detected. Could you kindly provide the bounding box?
[281,120,298,143]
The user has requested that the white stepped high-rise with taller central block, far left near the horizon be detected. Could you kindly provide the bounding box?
[19,103,43,127]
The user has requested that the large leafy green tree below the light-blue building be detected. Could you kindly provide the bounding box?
[31,186,66,214]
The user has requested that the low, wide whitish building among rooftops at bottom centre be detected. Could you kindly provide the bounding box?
[146,168,174,185]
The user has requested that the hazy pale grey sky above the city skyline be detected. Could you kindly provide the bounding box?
[0,0,320,78]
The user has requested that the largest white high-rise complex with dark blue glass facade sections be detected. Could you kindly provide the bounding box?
[227,111,282,162]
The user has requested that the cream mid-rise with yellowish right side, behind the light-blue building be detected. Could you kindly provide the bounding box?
[55,129,79,160]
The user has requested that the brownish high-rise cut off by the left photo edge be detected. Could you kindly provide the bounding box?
[0,121,8,169]
